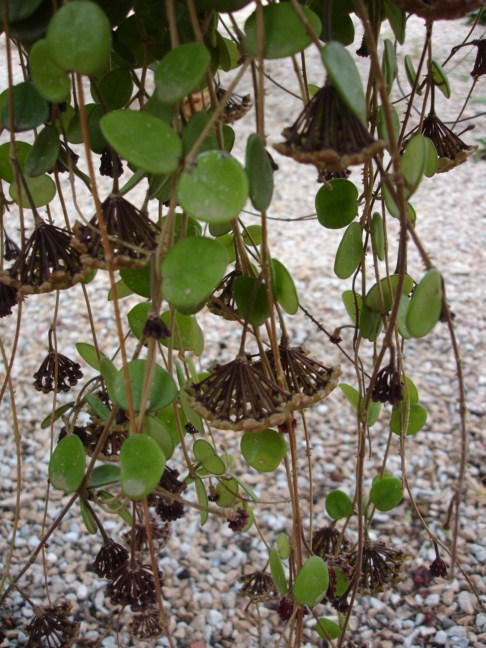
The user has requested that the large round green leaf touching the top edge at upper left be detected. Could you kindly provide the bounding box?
[46,0,111,75]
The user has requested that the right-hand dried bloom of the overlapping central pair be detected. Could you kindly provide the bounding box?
[257,336,341,409]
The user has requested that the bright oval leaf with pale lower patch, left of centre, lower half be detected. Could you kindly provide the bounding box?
[120,434,165,500]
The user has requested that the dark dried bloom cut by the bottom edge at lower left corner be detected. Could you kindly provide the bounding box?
[25,602,79,648]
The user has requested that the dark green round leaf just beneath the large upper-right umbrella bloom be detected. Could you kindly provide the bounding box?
[315,178,358,229]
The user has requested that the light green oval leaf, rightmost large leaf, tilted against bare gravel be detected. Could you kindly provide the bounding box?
[406,268,442,338]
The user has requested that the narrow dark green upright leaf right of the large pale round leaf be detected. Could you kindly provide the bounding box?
[245,133,273,212]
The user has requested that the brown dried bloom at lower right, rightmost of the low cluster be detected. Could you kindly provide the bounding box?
[349,542,405,595]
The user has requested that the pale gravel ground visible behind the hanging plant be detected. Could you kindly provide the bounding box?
[0,12,486,648]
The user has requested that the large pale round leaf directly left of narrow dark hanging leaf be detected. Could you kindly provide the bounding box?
[177,151,248,223]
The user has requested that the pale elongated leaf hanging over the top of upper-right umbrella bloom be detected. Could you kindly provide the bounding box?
[321,41,367,126]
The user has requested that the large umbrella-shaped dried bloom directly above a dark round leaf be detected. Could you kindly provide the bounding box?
[274,83,386,172]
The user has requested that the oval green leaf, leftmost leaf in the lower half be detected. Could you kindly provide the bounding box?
[49,434,86,493]
